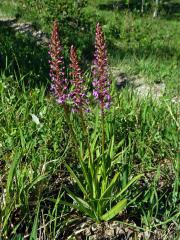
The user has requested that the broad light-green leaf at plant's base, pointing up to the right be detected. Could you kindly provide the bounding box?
[101,199,127,221]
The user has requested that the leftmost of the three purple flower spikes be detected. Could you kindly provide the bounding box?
[49,21,68,104]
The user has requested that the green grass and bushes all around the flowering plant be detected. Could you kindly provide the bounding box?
[0,0,180,239]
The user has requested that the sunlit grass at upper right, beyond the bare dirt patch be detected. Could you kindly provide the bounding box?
[86,1,180,96]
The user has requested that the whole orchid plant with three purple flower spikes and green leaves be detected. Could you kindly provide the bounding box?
[49,21,142,222]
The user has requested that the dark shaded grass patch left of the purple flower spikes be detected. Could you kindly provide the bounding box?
[0,20,49,87]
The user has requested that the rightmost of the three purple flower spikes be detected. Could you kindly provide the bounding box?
[92,23,111,110]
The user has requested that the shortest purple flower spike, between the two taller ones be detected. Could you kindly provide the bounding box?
[70,46,87,112]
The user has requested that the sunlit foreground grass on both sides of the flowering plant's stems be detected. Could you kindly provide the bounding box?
[0,67,179,239]
